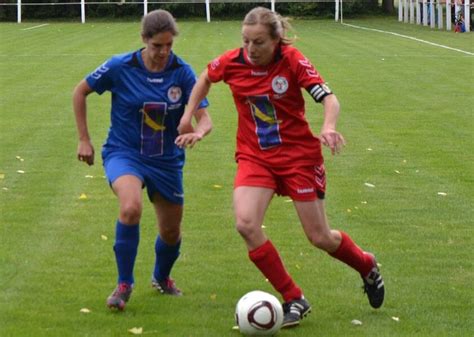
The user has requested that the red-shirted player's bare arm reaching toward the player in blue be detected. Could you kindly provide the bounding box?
[178,69,212,135]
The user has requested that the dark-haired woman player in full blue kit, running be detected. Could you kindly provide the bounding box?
[73,10,212,310]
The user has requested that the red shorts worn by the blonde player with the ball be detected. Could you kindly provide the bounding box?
[234,159,326,201]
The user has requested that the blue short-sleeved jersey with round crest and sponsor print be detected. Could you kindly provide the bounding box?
[86,50,208,168]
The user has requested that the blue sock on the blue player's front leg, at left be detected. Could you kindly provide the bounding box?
[114,220,140,284]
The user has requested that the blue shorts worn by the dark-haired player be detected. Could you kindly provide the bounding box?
[104,152,184,205]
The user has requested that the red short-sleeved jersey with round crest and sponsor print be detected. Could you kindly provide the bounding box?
[208,45,331,167]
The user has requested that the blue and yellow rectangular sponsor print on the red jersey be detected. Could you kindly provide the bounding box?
[248,95,282,150]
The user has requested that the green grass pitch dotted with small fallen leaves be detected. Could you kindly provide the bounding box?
[0,19,474,337]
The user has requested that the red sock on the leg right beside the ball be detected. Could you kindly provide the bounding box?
[249,240,303,302]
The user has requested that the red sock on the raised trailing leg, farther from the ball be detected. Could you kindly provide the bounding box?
[329,231,374,277]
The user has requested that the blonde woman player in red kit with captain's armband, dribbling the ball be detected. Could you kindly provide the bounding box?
[178,7,384,327]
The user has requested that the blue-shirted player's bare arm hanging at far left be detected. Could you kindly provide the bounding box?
[72,80,94,165]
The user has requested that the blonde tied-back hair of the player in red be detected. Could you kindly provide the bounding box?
[242,7,294,45]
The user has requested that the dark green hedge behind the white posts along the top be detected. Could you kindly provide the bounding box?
[0,0,386,21]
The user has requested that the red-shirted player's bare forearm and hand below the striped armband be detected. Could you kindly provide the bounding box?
[320,94,346,155]
